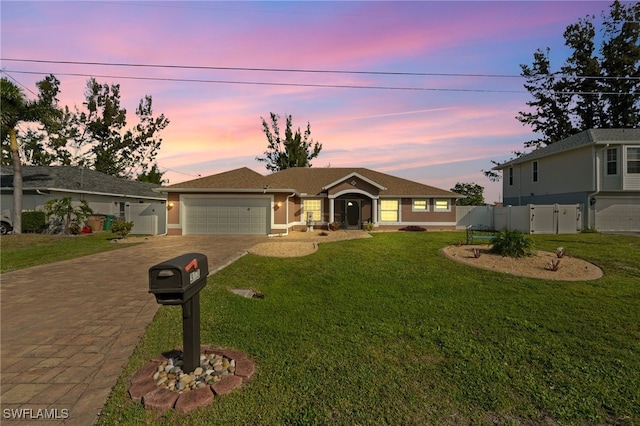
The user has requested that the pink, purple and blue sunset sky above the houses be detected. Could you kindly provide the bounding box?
[0,0,610,203]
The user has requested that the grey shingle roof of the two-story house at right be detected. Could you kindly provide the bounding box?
[493,129,640,170]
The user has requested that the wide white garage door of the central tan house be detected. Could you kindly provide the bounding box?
[184,198,270,235]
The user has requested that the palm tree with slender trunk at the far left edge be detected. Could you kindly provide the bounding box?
[0,75,61,234]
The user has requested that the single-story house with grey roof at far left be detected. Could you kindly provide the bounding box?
[0,166,167,235]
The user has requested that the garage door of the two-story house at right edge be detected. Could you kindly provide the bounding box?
[596,198,640,231]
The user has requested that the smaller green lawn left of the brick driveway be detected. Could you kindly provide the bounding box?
[0,232,130,272]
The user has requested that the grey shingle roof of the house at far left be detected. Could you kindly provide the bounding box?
[0,166,165,200]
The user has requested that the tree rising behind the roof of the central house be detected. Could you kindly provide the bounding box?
[256,112,322,172]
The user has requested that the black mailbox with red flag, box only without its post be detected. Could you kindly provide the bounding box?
[149,253,209,305]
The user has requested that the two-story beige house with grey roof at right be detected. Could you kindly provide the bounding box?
[494,129,640,231]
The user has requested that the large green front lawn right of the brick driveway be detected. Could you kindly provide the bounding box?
[99,232,640,425]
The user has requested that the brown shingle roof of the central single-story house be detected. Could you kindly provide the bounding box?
[167,167,459,197]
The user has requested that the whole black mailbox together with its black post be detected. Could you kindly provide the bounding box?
[149,253,209,372]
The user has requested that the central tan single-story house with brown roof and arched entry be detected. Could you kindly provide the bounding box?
[161,167,462,235]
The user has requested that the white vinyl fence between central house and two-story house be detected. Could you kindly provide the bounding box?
[456,204,583,234]
